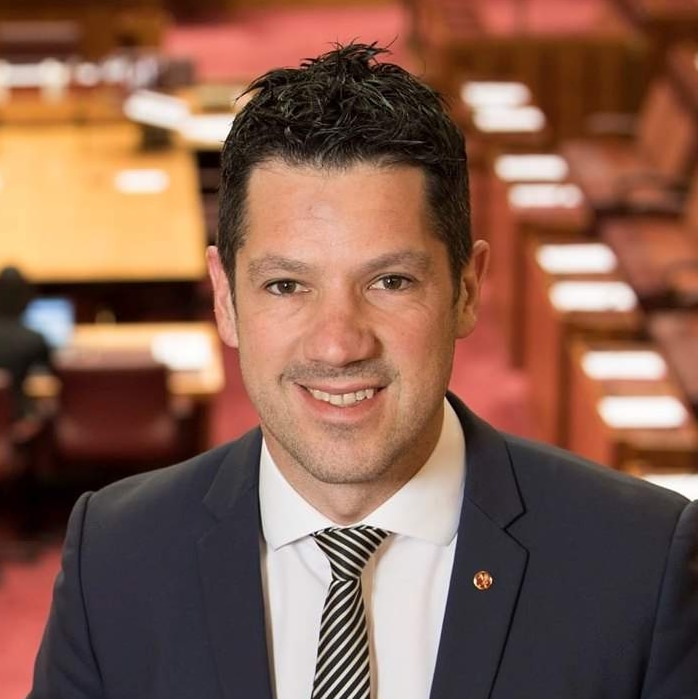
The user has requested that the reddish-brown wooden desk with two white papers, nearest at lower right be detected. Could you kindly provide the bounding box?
[564,340,698,472]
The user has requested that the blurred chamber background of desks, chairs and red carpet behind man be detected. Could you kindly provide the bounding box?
[0,0,698,699]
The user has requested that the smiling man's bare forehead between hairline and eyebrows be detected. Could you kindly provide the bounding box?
[231,159,439,266]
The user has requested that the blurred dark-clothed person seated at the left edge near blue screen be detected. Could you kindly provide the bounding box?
[0,267,50,419]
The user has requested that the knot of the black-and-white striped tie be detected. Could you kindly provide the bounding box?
[311,524,388,580]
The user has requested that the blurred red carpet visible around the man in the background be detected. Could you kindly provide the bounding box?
[0,5,530,699]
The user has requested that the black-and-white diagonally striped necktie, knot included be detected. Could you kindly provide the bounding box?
[312,525,388,699]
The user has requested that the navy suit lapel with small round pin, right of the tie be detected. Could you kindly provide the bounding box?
[431,396,527,699]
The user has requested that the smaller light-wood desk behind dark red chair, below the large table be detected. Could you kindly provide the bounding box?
[25,322,225,450]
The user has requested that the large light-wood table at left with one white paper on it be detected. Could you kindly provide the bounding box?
[0,124,206,284]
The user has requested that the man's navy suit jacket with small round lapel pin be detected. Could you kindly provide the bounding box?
[30,397,698,699]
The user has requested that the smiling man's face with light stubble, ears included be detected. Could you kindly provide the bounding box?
[209,162,487,509]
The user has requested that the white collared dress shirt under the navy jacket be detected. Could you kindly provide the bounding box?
[259,401,465,699]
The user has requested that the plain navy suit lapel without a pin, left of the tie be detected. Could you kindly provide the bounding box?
[199,431,272,699]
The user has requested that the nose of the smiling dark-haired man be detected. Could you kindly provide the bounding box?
[303,291,379,367]
